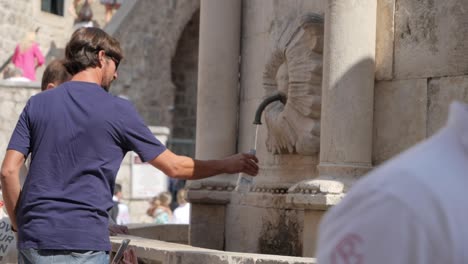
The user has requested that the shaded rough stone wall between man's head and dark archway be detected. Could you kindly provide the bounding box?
[112,0,200,129]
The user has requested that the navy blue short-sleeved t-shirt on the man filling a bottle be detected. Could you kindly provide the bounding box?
[8,81,166,251]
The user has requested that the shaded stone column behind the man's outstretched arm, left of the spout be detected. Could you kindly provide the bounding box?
[188,0,241,249]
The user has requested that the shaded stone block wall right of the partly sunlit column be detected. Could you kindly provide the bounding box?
[373,0,468,165]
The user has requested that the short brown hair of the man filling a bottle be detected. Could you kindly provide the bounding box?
[65,27,123,75]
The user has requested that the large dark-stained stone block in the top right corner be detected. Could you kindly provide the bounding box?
[394,0,468,79]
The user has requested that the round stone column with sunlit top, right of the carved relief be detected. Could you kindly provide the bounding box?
[287,0,377,256]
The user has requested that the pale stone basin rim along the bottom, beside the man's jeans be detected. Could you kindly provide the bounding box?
[110,236,316,264]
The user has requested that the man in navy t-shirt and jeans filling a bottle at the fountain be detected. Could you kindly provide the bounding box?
[1,28,258,263]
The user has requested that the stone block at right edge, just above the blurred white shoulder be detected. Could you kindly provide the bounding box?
[427,75,468,136]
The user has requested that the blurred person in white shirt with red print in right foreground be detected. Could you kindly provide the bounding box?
[316,102,468,264]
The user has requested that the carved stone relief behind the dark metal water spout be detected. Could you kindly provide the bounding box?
[263,15,323,155]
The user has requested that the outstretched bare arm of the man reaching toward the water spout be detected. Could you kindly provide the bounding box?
[149,150,258,180]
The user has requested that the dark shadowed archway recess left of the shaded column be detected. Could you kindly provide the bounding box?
[168,10,200,157]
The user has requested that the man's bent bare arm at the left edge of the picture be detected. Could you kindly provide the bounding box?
[1,150,25,230]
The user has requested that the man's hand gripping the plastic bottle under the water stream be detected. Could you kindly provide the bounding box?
[223,153,258,176]
